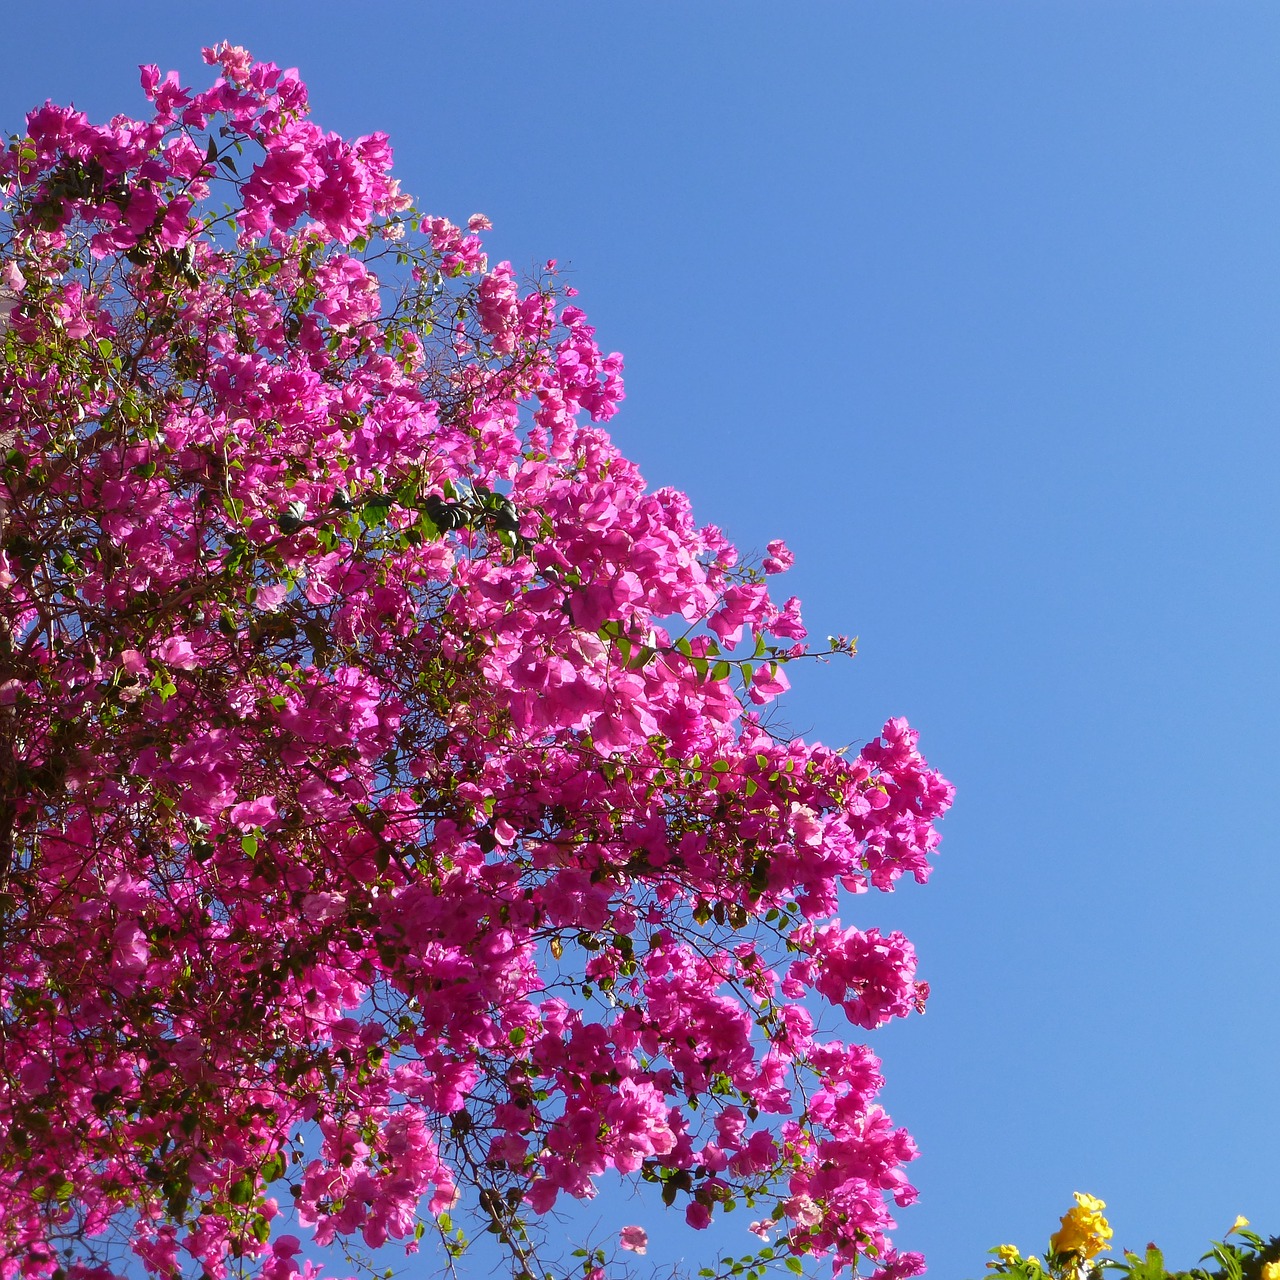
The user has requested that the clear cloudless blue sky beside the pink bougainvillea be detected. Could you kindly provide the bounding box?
[0,0,1280,1280]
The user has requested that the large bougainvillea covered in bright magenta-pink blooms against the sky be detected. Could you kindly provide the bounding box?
[0,46,951,1280]
